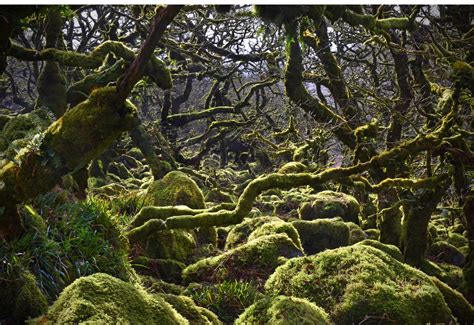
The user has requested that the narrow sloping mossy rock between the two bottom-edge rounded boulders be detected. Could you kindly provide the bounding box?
[158,293,222,325]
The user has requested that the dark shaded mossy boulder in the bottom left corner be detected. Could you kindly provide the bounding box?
[0,271,48,324]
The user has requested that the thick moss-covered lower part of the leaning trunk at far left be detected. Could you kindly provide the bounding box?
[0,87,136,238]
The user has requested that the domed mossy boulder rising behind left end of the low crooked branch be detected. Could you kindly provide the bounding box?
[147,171,205,209]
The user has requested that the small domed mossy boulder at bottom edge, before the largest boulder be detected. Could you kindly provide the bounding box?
[235,296,331,325]
